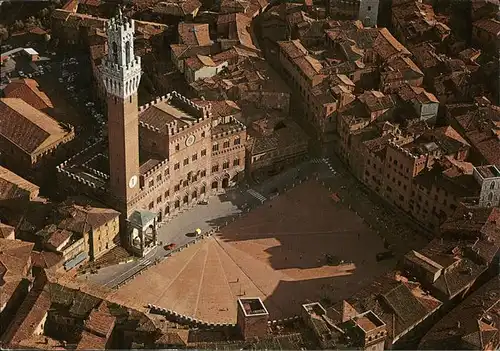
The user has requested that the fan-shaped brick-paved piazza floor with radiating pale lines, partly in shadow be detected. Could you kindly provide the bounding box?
[108,181,395,323]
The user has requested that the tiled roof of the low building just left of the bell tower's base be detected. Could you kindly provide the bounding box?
[58,205,120,234]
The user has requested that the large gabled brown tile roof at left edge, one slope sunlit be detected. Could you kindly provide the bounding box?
[0,98,69,154]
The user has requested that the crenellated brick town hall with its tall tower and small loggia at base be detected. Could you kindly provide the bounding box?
[58,12,247,255]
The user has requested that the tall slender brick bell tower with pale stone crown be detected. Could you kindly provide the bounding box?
[101,11,142,210]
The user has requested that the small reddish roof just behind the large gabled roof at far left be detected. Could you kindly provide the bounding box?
[3,79,54,110]
